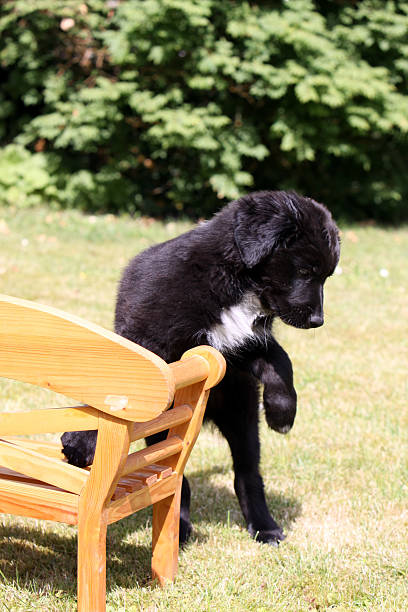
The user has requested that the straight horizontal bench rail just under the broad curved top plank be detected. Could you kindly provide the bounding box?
[0,406,98,436]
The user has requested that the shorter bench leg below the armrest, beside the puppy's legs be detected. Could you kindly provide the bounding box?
[152,476,183,585]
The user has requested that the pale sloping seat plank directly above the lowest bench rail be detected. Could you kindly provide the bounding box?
[0,441,89,493]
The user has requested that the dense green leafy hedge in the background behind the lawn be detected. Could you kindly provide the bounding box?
[0,0,408,220]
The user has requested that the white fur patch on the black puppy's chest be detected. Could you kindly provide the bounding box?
[207,293,262,350]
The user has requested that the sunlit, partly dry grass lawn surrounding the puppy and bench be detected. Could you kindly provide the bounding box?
[0,208,408,612]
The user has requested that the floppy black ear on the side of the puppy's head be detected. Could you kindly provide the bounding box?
[234,198,299,268]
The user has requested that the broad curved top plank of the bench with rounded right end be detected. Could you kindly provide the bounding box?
[0,295,175,421]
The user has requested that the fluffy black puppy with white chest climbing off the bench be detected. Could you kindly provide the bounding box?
[62,191,340,543]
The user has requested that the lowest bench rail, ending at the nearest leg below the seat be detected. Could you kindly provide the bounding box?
[0,479,79,525]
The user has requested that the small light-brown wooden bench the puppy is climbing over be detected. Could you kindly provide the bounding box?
[0,295,225,612]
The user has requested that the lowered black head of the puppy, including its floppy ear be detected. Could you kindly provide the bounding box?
[234,191,340,329]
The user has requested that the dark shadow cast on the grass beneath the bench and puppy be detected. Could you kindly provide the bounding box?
[0,466,301,596]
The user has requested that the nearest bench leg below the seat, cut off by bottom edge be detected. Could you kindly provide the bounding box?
[78,515,107,612]
